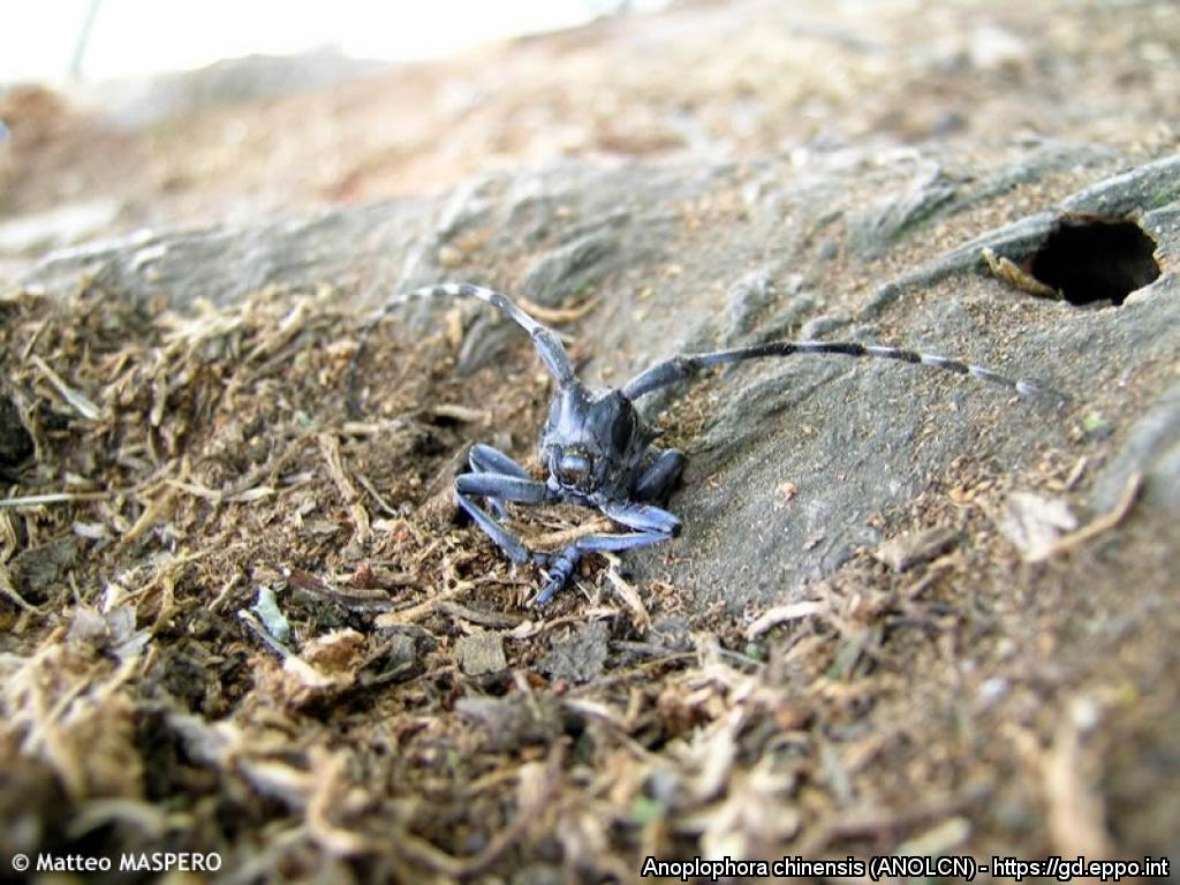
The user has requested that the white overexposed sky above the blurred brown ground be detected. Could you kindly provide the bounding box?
[0,0,664,84]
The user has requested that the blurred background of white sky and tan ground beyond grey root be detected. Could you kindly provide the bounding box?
[0,0,1180,270]
